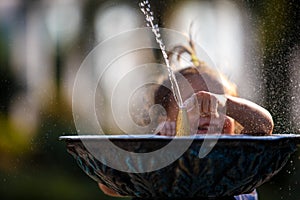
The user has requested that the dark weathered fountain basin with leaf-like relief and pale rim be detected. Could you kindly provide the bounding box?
[60,134,300,198]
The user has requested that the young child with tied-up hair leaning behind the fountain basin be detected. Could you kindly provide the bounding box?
[155,39,274,136]
